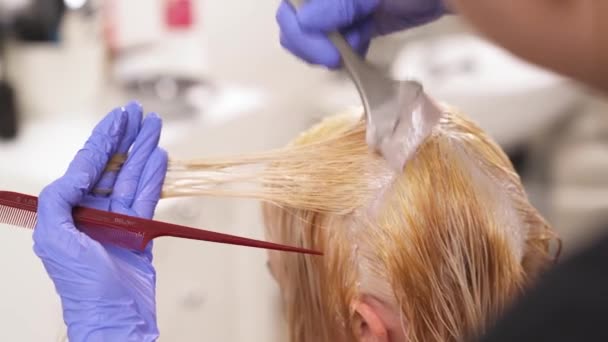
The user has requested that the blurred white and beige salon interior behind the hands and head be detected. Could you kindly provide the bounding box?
[0,0,608,342]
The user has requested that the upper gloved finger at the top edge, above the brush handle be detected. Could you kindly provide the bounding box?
[297,0,378,32]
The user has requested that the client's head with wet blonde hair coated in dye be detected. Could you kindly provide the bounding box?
[263,110,553,342]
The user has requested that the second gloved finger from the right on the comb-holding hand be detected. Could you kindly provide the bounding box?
[110,113,162,213]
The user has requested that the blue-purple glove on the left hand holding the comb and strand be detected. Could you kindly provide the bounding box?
[33,103,167,342]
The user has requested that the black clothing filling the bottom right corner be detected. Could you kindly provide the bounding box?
[480,226,608,342]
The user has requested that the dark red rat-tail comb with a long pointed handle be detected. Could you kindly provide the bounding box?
[0,191,323,255]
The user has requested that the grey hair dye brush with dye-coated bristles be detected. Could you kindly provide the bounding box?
[290,0,442,172]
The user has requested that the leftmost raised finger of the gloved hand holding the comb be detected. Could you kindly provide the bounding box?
[33,111,127,252]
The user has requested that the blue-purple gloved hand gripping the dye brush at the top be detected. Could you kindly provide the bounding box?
[277,0,447,69]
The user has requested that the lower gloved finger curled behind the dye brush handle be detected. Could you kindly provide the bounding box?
[277,3,372,69]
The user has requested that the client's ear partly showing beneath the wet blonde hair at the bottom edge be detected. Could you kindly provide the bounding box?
[353,299,390,342]
